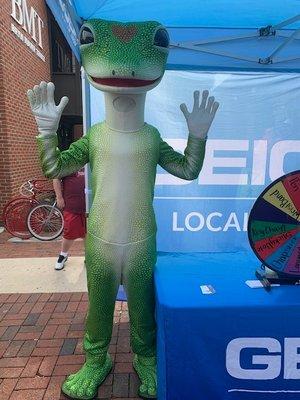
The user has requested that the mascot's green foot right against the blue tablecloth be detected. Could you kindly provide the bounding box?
[133,354,157,399]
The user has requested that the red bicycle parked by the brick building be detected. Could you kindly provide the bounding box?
[3,179,63,241]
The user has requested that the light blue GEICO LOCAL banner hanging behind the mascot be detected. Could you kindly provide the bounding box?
[91,71,300,252]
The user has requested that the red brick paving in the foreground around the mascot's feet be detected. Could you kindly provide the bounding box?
[0,293,138,400]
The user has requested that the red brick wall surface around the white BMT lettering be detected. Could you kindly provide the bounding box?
[0,0,50,220]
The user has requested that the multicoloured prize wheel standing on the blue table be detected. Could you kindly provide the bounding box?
[248,171,300,278]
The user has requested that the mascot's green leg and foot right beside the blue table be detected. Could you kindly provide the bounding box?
[123,236,157,398]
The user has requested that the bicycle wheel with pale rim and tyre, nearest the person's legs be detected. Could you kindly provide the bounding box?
[27,203,64,241]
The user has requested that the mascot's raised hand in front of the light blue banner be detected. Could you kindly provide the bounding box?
[180,90,219,139]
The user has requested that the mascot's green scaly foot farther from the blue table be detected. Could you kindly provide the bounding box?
[61,354,112,400]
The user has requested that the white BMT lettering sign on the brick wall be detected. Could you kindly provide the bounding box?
[10,0,45,62]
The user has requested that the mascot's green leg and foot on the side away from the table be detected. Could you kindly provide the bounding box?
[62,235,121,399]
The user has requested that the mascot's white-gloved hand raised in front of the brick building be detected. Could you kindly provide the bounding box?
[27,81,69,136]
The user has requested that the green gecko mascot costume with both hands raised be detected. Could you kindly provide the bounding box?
[27,19,218,399]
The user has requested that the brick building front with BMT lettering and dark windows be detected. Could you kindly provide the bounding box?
[0,0,82,220]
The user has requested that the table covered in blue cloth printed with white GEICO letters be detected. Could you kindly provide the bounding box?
[155,253,300,400]
